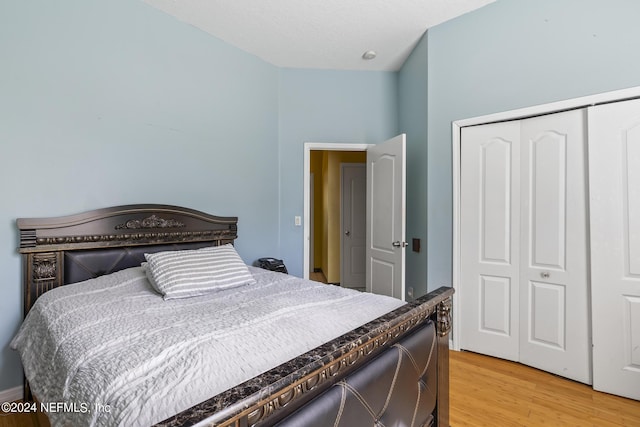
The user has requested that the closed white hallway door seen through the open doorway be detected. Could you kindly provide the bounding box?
[340,163,367,291]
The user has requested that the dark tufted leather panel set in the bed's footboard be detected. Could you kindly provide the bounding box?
[276,321,438,427]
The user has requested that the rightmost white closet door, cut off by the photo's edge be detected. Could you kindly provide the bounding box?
[589,100,640,400]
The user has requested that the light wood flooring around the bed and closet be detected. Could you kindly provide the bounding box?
[0,351,640,427]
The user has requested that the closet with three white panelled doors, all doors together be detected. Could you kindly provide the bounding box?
[458,100,640,399]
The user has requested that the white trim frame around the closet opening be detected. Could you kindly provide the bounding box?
[451,86,640,351]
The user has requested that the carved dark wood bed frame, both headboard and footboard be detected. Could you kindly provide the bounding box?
[17,204,453,427]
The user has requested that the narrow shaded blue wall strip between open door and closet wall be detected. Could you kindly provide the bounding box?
[398,35,428,298]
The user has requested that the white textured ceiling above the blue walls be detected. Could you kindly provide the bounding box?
[143,0,495,71]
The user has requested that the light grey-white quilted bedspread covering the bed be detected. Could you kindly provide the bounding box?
[11,267,403,426]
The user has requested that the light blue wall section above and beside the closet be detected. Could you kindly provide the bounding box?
[427,0,640,289]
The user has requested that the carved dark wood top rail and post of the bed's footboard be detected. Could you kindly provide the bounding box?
[157,287,453,427]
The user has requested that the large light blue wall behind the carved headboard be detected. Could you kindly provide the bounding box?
[0,0,280,391]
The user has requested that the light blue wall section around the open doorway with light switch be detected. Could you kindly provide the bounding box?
[279,69,398,276]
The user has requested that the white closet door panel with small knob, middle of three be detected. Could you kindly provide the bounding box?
[520,110,591,384]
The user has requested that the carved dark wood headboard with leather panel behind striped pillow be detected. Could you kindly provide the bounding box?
[17,204,238,316]
